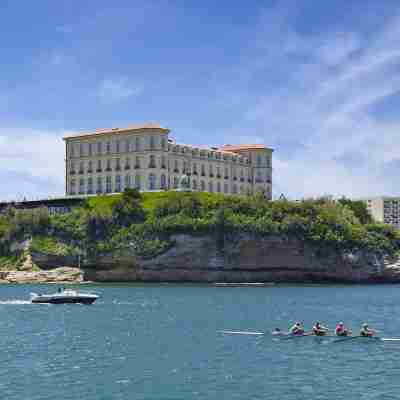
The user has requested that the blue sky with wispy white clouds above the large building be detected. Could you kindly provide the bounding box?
[0,0,400,200]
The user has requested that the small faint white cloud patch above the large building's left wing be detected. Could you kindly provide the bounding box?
[97,78,143,102]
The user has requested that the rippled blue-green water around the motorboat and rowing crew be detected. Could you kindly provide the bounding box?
[0,284,400,400]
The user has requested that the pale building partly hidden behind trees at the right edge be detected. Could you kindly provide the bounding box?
[363,197,400,229]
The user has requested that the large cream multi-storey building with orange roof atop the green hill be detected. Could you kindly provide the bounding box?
[64,124,273,199]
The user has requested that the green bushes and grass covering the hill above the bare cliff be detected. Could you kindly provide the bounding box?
[0,190,400,258]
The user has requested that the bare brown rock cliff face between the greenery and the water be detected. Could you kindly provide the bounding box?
[71,234,400,283]
